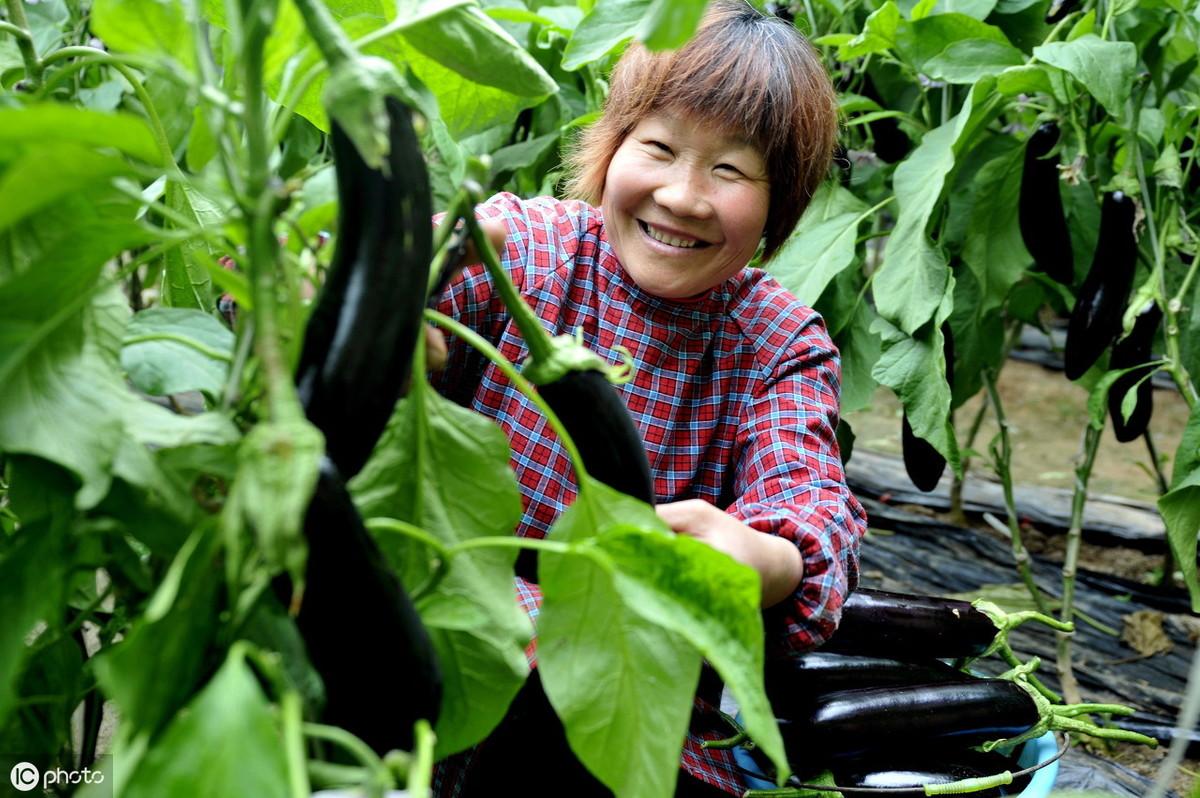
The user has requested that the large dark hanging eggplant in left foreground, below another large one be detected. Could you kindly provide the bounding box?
[292,457,442,756]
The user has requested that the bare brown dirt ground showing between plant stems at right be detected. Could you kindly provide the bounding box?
[846,360,1200,798]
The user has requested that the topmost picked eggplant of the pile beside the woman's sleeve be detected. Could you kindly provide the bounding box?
[821,588,998,661]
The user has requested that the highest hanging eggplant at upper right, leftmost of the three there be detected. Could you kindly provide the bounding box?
[1018,122,1075,286]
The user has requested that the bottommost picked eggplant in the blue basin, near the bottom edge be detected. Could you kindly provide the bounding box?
[833,749,1032,798]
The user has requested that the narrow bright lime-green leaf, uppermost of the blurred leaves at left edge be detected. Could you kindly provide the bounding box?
[0,103,162,164]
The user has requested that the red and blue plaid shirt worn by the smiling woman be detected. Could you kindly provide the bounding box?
[434,193,866,794]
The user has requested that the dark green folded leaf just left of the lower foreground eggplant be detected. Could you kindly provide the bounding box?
[92,524,221,733]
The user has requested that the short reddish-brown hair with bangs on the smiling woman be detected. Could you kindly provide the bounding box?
[566,0,838,260]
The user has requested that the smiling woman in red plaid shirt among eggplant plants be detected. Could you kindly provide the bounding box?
[422,0,865,796]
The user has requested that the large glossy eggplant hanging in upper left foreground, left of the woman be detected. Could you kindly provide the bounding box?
[296,97,433,480]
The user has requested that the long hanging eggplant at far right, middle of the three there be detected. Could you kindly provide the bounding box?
[1063,191,1138,379]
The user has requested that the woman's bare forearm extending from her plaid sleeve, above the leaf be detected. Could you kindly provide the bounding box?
[655,499,804,607]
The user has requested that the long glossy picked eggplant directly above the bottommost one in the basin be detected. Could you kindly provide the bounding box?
[779,679,1040,762]
